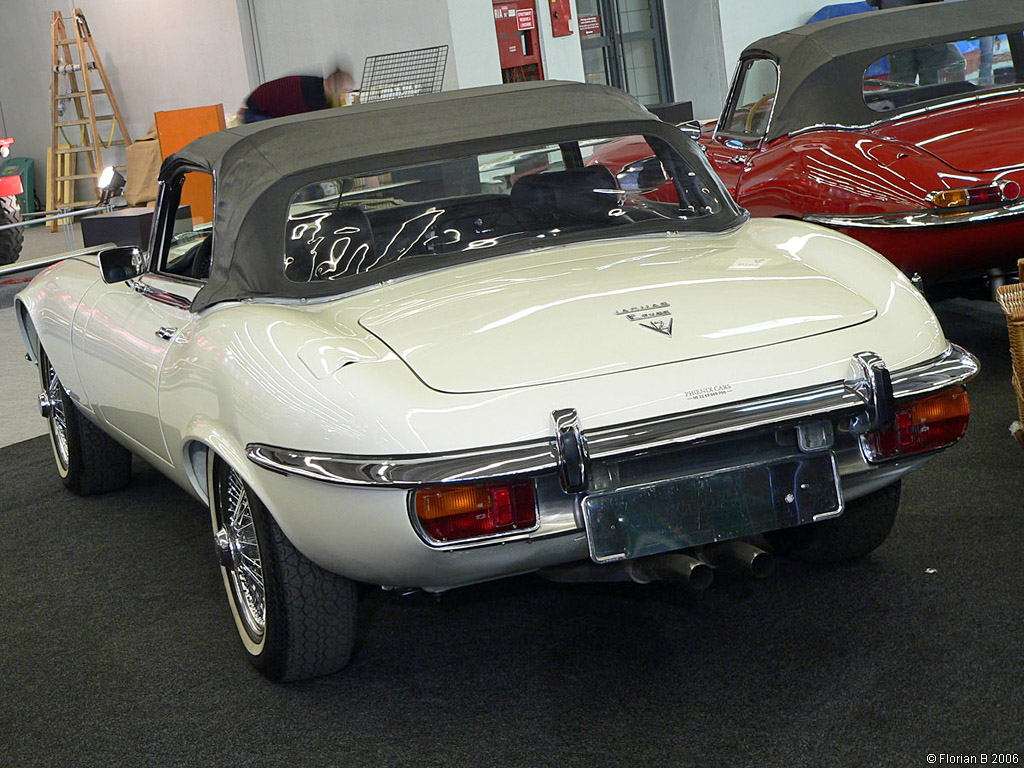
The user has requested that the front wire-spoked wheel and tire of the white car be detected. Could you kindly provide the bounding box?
[39,347,131,496]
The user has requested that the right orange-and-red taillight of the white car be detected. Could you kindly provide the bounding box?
[867,387,971,461]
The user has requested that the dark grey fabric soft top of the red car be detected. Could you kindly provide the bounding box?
[740,0,1024,140]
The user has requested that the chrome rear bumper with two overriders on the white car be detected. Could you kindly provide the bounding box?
[246,344,979,492]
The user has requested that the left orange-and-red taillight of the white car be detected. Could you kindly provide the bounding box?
[416,481,537,542]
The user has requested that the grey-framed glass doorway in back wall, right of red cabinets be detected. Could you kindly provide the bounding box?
[577,0,672,104]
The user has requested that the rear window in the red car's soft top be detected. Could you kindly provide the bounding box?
[863,32,1024,112]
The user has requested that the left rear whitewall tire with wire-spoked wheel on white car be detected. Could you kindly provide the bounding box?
[210,459,356,682]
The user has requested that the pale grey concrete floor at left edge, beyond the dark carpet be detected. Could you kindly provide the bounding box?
[0,226,82,447]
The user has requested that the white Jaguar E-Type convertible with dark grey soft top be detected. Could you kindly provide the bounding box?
[16,82,978,680]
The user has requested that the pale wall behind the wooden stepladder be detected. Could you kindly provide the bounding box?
[0,0,249,203]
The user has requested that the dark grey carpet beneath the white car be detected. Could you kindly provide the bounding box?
[0,300,1024,767]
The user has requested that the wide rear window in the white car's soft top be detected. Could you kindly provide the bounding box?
[283,136,722,283]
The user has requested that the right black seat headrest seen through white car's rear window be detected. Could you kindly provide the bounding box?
[510,165,620,228]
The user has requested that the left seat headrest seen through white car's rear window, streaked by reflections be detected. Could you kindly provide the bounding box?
[285,207,374,283]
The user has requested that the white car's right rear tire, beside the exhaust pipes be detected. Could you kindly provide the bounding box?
[764,480,901,563]
